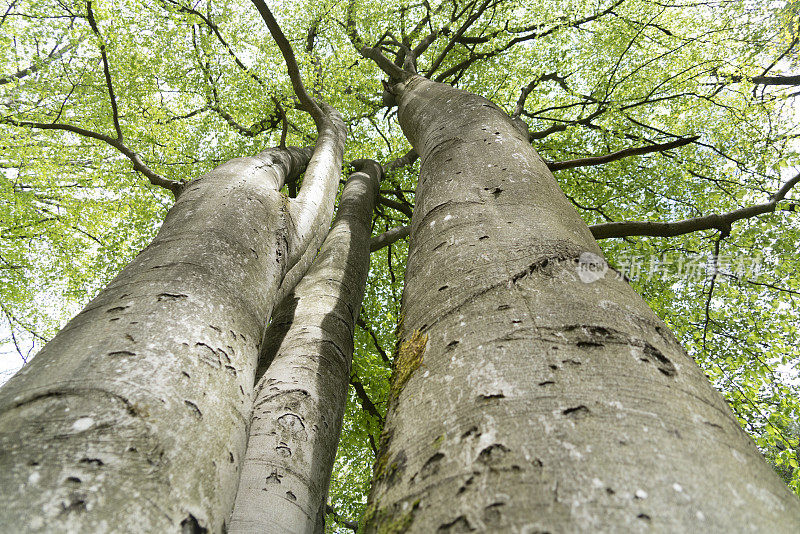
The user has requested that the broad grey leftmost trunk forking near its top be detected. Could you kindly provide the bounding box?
[0,112,345,533]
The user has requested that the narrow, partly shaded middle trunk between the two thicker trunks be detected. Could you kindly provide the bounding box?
[229,161,381,533]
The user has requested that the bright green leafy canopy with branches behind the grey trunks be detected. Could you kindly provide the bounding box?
[0,0,800,528]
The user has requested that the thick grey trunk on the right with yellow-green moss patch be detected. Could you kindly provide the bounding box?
[367,77,800,533]
